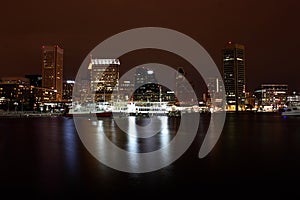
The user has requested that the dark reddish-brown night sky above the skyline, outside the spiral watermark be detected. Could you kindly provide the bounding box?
[0,0,300,91]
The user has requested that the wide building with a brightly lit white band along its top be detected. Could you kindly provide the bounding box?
[88,59,120,102]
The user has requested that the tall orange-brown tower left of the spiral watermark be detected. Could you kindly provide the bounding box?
[42,45,63,101]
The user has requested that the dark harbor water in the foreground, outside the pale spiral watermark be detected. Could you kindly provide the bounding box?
[0,113,300,199]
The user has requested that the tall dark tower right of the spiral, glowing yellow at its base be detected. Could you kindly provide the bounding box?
[222,42,246,111]
